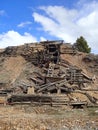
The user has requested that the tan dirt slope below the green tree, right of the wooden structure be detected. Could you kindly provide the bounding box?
[61,52,98,83]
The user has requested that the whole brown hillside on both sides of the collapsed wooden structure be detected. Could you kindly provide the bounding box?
[0,43,98,104]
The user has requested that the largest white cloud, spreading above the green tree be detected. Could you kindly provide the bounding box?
[32,0,98,53]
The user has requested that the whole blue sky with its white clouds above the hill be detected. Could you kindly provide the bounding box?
[0,0,98,54]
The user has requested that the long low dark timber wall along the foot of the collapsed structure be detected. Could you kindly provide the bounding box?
[7,94,87,108]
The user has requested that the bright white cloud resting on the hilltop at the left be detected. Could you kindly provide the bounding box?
[0,30,37,48]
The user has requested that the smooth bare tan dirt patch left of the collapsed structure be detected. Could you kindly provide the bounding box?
[0,56,26,85]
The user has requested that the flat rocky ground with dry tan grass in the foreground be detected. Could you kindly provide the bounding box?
[0,105,98,130]
